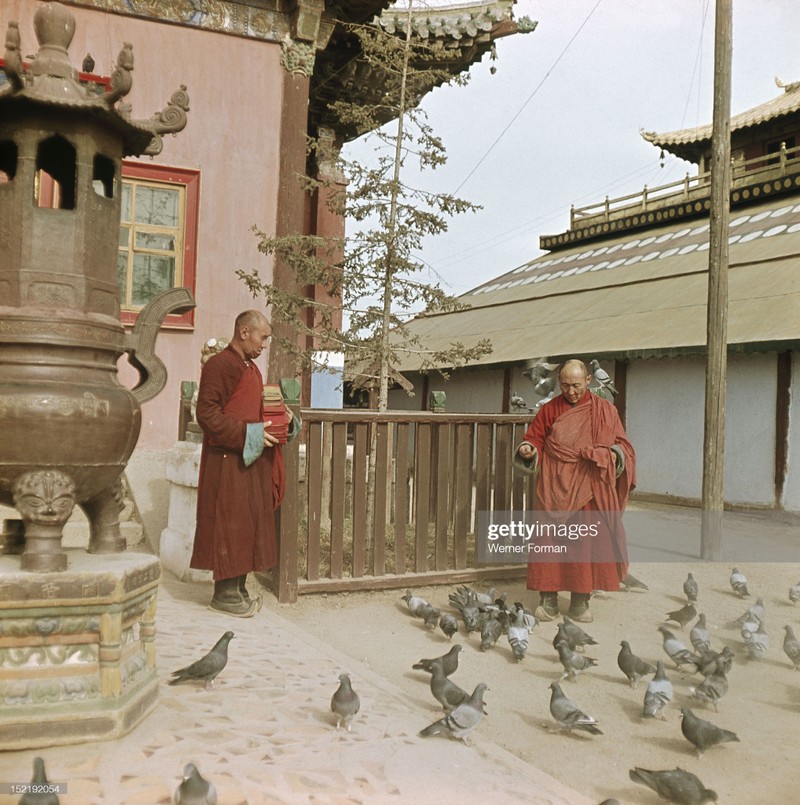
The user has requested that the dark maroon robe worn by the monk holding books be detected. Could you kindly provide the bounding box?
[190,346,282,580]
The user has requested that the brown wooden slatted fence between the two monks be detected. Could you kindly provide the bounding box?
[273,409,533,602]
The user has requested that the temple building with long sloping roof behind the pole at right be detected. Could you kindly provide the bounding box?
[390,77,800,512]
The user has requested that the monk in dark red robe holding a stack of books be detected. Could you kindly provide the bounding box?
[190,310,297,618]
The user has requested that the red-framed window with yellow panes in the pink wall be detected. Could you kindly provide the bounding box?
[117,161,200,327]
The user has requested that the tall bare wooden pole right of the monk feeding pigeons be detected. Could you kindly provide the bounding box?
[700,0,732,560]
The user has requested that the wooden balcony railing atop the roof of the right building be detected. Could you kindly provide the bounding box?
[570,143,800,229]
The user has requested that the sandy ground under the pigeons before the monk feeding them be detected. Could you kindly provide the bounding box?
[280,560,800,805]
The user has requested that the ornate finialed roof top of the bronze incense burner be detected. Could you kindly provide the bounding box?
[0,3,189,156]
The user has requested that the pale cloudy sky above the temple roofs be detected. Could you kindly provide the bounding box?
[348,0,800,295]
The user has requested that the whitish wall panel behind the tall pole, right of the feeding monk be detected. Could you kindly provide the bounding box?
[627,353,777,505]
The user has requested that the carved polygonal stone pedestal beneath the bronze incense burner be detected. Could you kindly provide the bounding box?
[0,550,161,750]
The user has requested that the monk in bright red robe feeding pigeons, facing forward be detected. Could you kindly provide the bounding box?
[515,360,636,623]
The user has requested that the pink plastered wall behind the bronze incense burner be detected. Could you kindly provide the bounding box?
[5,0,283,451]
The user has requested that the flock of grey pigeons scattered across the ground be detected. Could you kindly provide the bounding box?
[14,568,800,805]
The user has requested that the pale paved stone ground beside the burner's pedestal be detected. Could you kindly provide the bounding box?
[0,577,589,805]
